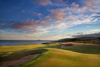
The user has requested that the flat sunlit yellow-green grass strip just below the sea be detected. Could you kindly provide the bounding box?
[0,44,47,53]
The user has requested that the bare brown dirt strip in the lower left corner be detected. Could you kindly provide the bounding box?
[0,54,39,67]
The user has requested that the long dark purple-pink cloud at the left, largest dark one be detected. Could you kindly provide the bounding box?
[0,18,37,30]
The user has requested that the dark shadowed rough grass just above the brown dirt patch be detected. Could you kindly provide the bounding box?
[0,49,47,62]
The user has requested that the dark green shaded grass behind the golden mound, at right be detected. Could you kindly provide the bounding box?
[62,45,100,54]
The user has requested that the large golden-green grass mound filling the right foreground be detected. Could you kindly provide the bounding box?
[19,48,100,67]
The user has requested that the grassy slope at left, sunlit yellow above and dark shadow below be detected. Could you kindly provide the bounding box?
[0,43,59,62]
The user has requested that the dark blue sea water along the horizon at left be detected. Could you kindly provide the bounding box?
[0,40,50,46]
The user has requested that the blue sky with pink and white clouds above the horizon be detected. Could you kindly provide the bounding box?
[0,0,100,40]
